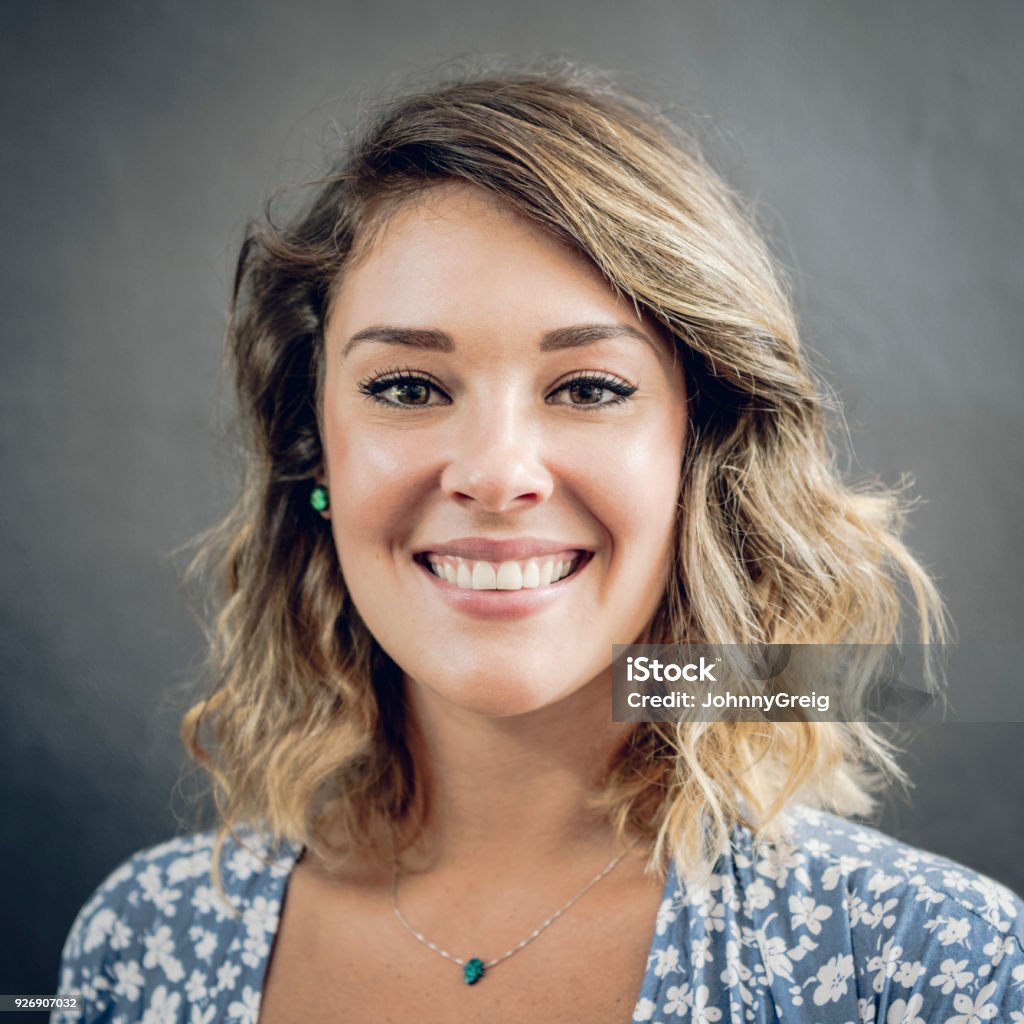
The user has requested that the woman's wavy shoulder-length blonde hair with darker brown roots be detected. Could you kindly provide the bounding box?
[182,64,947,877]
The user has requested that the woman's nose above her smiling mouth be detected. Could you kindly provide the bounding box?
[441,400,554,514]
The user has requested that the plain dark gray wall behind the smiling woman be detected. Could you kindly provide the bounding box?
[0,0,1024,992]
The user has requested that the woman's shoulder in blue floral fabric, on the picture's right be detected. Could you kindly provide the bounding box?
[644,808,1024,1024]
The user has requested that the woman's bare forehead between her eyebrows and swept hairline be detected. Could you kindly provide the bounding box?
[329,184,641,332]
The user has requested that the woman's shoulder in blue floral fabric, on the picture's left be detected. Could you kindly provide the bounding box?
[55,829,299,1021]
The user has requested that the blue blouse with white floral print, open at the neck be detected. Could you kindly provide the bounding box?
[51,808,1024,1024]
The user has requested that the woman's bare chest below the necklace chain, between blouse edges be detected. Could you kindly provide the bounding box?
[259,860,662,1024]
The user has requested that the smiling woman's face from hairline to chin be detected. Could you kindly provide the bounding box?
[323,185,687,716]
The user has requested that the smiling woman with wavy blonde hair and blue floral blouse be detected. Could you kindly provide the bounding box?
[58,68,1024,1024]
